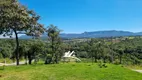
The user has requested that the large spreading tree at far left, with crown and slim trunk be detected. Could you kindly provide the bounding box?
[0,0,44,65]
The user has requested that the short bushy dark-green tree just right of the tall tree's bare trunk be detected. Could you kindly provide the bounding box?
[24,39,45,64]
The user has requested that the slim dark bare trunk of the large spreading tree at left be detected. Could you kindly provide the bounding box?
[13,29,19,65]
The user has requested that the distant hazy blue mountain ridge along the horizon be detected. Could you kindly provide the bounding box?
[20,30,142,39]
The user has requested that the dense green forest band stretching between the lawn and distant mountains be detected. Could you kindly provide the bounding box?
[0,36,142,65]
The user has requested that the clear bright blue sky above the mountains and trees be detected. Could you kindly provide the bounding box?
[20,0,142,33]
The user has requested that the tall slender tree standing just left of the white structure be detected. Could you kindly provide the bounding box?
[46,25,61,63]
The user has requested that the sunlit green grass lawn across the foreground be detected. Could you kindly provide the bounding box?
[0,63,142,80]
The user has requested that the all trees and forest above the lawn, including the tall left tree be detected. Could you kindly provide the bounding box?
[0,0,142,65]
